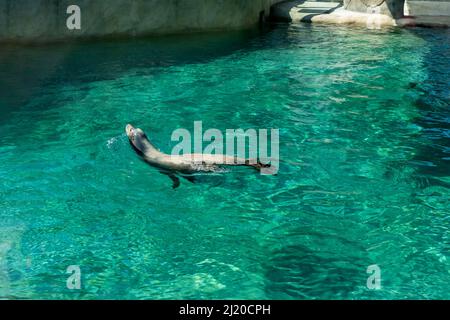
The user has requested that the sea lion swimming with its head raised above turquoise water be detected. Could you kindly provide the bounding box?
[125,124,270,189]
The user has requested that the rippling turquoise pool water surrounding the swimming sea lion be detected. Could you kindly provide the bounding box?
[0,24,450,299]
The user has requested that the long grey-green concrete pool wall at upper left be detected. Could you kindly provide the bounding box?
[0,0,281,42]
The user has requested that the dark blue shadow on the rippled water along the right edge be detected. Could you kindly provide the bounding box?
[409,28,450,182]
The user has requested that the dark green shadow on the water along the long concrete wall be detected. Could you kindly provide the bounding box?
[0,29,274,121]
